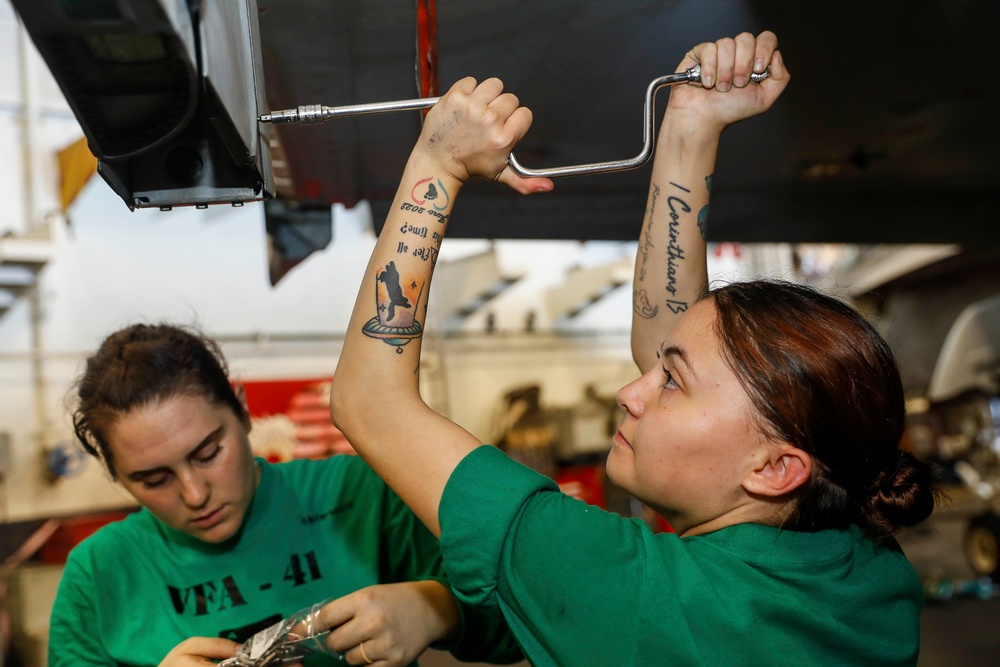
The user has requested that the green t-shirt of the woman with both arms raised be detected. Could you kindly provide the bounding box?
[439,446,923,667]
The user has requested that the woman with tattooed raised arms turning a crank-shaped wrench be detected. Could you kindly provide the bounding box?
[331,32,933,666]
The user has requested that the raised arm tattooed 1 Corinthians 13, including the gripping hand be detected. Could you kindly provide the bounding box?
[632,31,789,373]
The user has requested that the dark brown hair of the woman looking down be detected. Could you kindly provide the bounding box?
[73,324,250,478]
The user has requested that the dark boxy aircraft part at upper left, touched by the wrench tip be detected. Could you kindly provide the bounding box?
[13,0,274,208]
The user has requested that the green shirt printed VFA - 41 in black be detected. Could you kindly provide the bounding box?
[48,456,520,667]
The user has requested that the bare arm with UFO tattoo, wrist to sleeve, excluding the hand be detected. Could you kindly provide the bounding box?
[331,150,479,533]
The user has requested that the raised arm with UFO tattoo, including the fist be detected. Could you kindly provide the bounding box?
[330,78,552,535]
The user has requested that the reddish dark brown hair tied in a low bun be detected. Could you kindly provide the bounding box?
[706,281,934,540]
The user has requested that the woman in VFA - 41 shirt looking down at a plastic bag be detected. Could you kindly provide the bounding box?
[54,324,521,667]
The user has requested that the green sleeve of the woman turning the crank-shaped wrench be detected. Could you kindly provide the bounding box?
[439,446,652,664]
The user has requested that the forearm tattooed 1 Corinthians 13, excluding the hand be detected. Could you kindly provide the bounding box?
[632,112,721,373]
